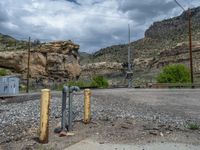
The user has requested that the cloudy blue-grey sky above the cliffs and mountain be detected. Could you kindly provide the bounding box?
[0,0,200,52]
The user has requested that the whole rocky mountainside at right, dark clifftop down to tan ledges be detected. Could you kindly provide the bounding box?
[81,7,200,80]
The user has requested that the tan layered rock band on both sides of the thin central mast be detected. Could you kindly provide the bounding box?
[81,41,200,82]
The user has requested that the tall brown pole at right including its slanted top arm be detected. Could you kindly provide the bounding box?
[174,0,194,84]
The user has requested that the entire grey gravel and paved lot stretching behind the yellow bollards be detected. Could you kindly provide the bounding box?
[0,89,200,149]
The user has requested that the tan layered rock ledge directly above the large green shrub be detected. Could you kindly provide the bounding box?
[133,41,200,81]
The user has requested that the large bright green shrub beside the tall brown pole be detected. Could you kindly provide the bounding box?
[157,64,190,83]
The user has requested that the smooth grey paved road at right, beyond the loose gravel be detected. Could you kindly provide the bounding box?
[93,89,200,120]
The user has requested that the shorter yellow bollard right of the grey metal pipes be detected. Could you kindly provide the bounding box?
[83,89,91,124]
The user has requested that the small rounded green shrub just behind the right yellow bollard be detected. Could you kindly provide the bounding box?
[91,76,109,88]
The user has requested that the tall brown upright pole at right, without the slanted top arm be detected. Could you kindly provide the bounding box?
[188,8,194,84]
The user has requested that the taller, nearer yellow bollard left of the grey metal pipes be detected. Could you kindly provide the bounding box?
[39,89,51,144]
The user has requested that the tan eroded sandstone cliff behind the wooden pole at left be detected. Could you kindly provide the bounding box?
[0,41,81,82]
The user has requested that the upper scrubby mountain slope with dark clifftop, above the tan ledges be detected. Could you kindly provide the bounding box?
[88,7,200,62]
